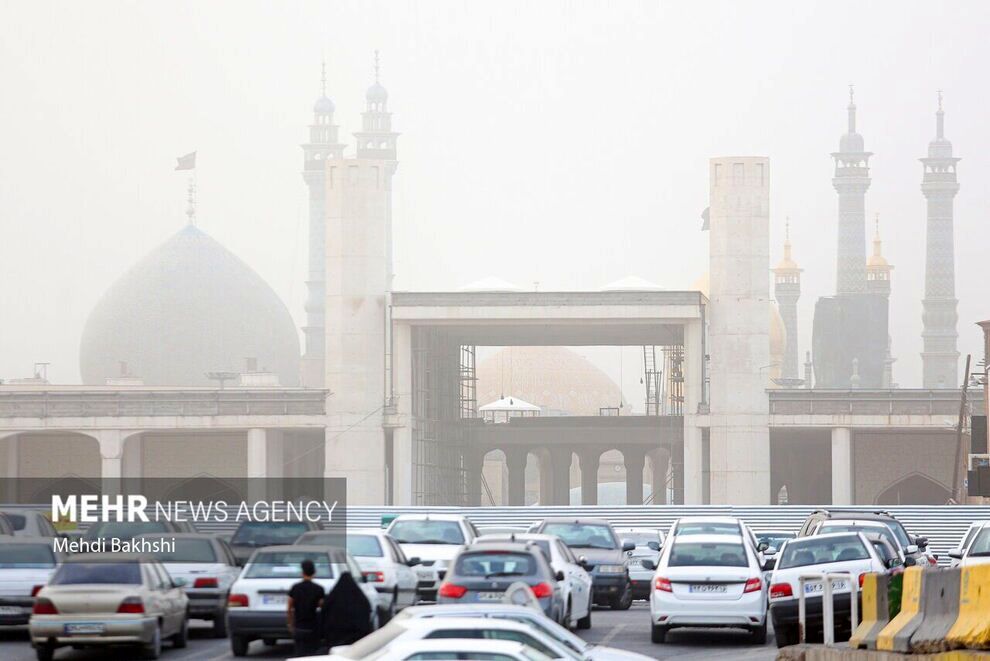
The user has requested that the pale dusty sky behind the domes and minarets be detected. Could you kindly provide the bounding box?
[0,0,990,399]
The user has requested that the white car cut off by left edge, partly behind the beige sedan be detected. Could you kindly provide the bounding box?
[0,537,65,626]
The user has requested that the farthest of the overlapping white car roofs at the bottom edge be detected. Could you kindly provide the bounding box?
[398,603,649,661]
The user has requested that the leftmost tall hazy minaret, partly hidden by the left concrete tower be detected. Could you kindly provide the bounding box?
[302,62,344,388]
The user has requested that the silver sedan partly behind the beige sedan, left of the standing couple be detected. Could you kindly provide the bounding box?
[142,532,241,638]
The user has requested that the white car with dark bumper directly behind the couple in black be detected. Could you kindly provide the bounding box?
[227,544,378,656]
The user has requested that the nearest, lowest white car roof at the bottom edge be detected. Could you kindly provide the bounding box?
[302,638,551,661]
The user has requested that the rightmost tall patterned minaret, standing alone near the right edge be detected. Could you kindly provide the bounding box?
[921,91,960,388]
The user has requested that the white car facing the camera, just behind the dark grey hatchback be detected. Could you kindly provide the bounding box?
[386,514,478,601]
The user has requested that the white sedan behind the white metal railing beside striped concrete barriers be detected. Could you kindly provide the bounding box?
[770,532,890,647]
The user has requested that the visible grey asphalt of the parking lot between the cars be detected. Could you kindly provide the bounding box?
[0,601,777,661]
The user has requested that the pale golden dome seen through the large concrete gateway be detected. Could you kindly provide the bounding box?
[477,347,624,415]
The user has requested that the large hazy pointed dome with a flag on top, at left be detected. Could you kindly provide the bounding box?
[80,225,299,386]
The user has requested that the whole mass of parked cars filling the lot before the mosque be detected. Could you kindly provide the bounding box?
[0,509,990,661]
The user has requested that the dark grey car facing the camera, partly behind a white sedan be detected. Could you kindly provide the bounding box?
[536,518,636,610]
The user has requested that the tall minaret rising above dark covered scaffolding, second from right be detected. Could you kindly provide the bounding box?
[832,85,873,295]
